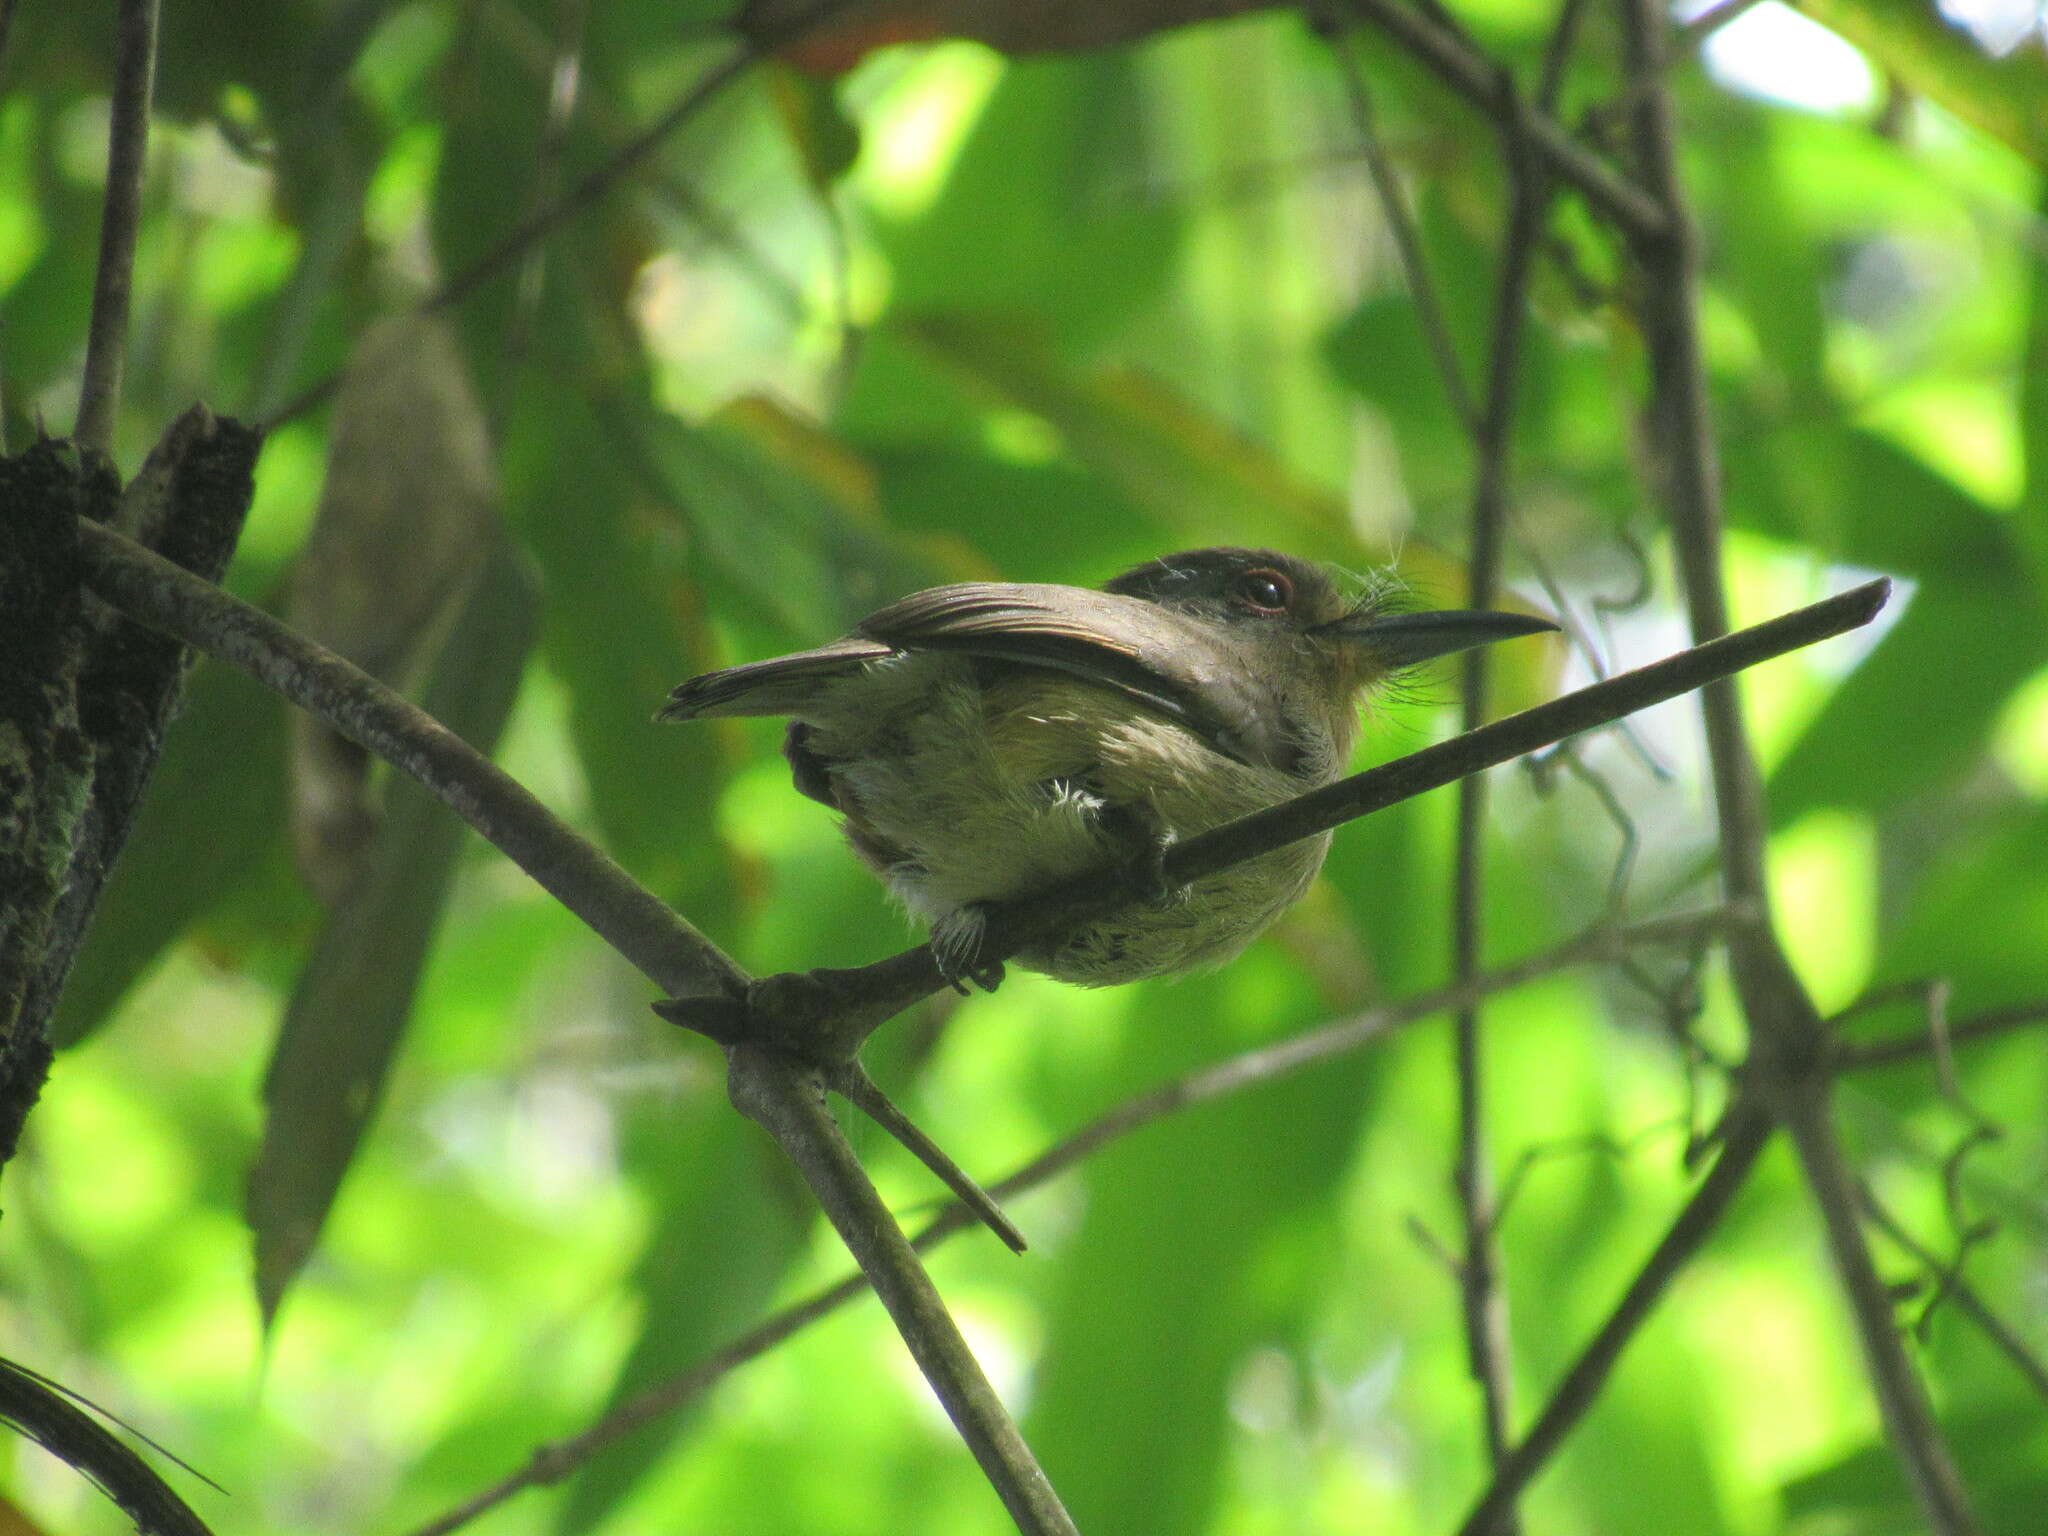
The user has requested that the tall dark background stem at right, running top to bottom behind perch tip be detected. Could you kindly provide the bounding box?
[1613,0,1976,1536]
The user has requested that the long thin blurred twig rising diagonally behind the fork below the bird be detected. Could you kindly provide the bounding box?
[395,909,1729,1536]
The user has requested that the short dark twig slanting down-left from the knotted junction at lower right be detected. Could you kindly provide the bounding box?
[1458,1102,1772,1536]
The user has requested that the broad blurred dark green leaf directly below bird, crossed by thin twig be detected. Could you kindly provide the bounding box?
[1024,954,1368,1536]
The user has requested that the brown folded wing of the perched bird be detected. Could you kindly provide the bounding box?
[856,582,1268,762]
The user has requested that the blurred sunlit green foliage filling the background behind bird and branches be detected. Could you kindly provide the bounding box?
[0,0,2048,1536]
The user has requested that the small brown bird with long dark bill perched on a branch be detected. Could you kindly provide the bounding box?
[657,547,1556,991]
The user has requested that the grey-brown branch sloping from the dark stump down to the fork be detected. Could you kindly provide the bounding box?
[78,520,748,995]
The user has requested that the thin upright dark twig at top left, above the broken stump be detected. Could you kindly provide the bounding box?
[78,0,158,453]
